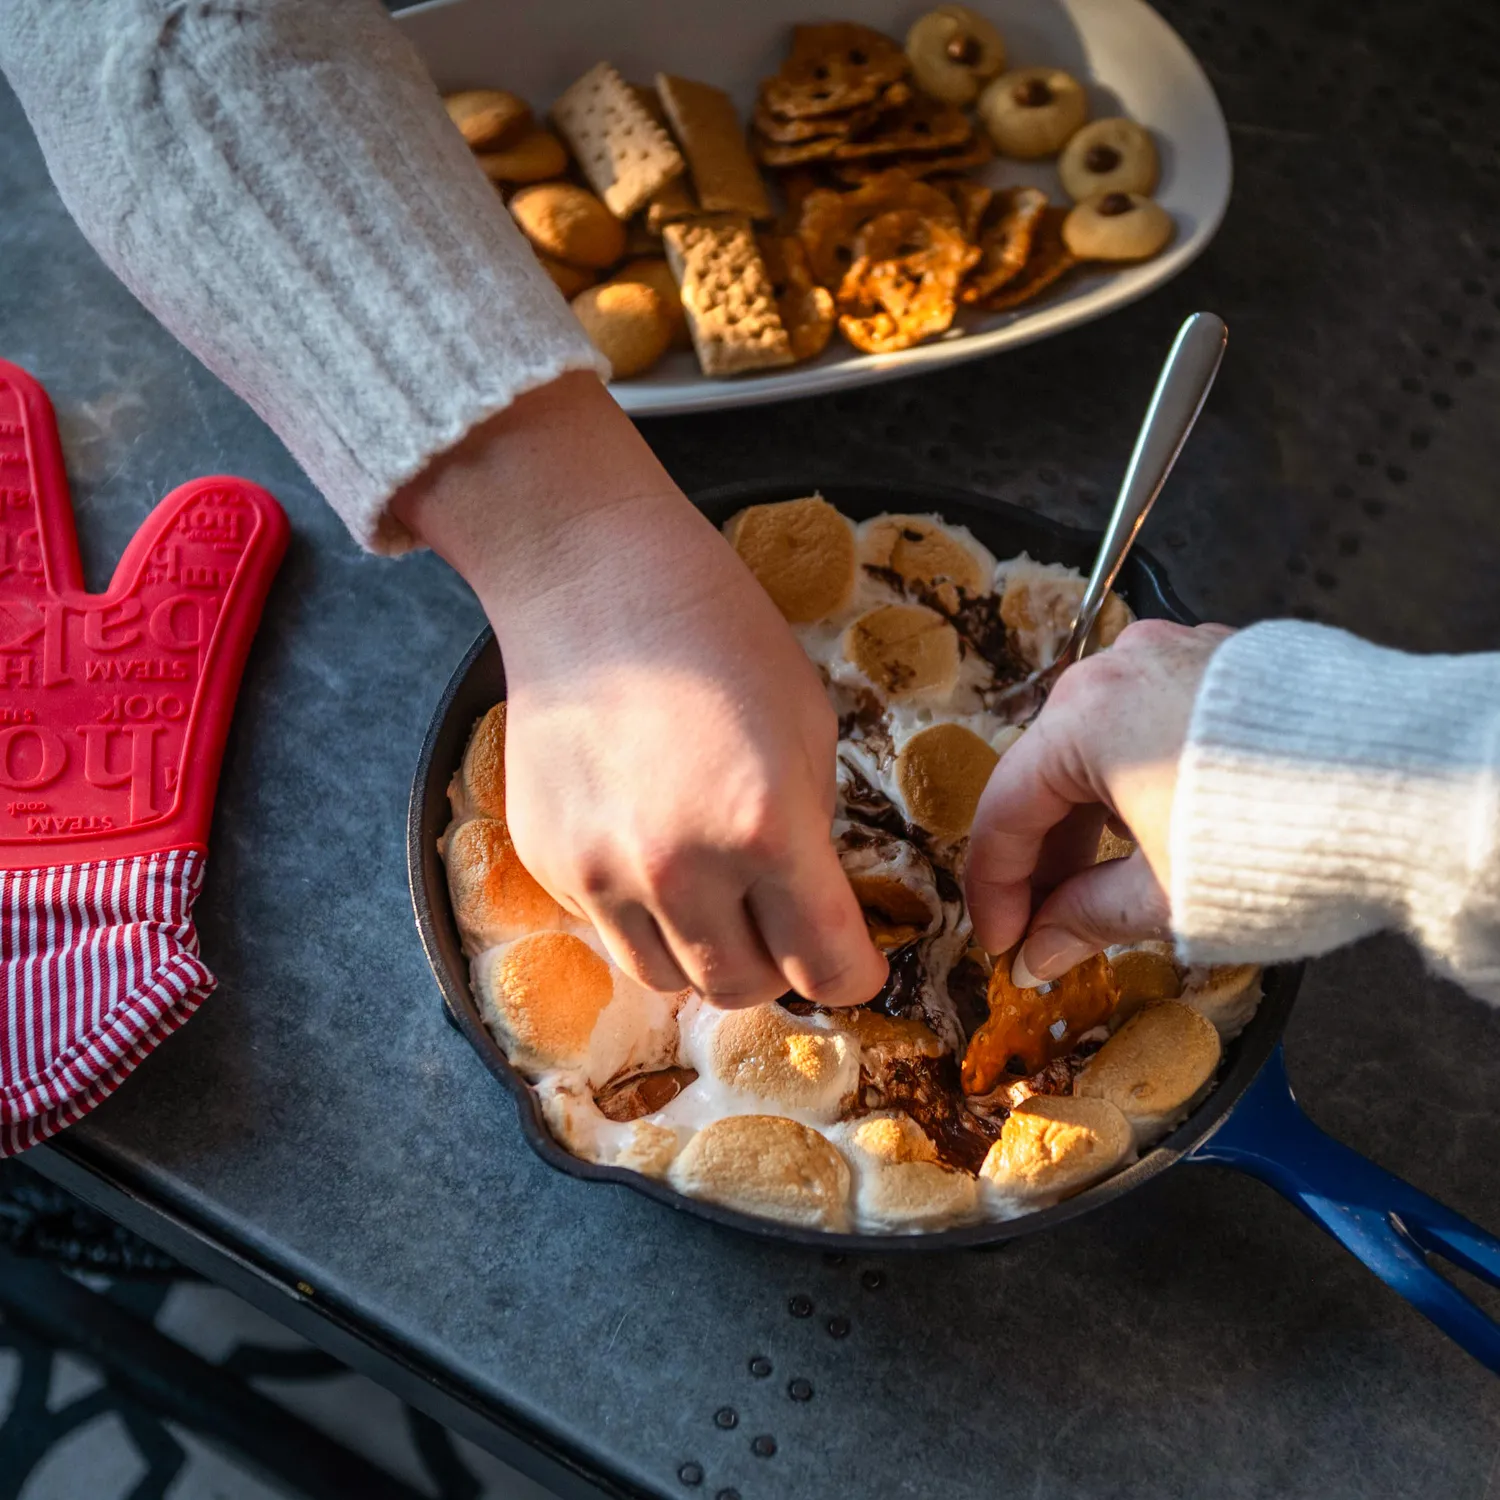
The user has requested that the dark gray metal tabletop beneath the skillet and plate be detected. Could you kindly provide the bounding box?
[0,0,1500,1500]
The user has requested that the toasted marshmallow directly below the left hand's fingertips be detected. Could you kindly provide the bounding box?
[681,1001,860,1121]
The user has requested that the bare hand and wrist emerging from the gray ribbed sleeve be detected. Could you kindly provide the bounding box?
[392,375,887,1005]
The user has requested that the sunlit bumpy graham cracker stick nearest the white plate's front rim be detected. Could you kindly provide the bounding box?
[662,215,795,375]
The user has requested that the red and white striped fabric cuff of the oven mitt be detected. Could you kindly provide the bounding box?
[0,849,215,1157]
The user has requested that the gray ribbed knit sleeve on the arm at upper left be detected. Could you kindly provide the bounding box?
[0,0,606,552]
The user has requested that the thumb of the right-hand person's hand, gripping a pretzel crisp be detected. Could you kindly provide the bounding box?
[1011,851,1172,989]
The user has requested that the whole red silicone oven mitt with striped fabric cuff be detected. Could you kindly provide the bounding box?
[0,360,288,1157]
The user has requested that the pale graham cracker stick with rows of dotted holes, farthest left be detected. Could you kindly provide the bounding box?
[552,63,687,219]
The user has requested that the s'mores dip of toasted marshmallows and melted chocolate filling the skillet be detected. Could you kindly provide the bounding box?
[441,495,1262,1235]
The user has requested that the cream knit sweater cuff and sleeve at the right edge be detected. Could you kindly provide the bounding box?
[1170,621,1500,1001]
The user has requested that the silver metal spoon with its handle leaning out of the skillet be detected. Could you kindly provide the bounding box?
[993,312,1229,717]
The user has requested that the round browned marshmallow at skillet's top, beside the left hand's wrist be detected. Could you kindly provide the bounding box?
[725,495,855,626]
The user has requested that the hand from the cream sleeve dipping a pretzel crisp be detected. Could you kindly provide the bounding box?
[966,620,1232,986]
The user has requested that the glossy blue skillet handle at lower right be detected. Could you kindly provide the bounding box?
[1188,1046,1500,1374]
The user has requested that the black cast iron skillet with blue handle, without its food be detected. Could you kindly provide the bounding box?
[407,483,1500,1371]
